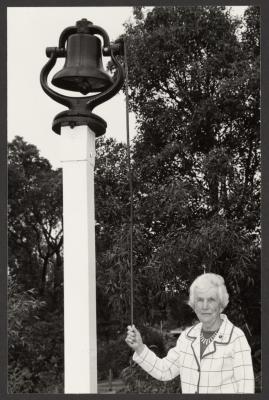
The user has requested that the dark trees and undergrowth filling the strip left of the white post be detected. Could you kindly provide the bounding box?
[8,136,63,393]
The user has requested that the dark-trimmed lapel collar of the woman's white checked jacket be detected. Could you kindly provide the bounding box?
[186,314,234,366]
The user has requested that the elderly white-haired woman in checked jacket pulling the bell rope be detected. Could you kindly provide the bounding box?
[126,273,254,393]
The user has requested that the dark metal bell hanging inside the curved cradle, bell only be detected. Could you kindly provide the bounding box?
[52,33,113,94]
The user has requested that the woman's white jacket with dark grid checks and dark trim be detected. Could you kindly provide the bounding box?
[133,314,254,393]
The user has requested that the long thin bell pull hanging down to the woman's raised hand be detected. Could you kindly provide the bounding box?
[124,39,134,325]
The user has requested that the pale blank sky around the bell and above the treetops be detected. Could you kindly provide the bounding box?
[7,6,246,168]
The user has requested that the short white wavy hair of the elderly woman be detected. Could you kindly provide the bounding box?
[188,273,229,310]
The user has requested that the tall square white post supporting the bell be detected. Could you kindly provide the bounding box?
[61,126,97,393]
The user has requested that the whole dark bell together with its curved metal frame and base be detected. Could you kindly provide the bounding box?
[40,19,124,137]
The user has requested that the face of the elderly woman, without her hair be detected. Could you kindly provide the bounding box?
[194,286,222,330]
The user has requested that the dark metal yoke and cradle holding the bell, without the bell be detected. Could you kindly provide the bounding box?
[40,18,124,137]
